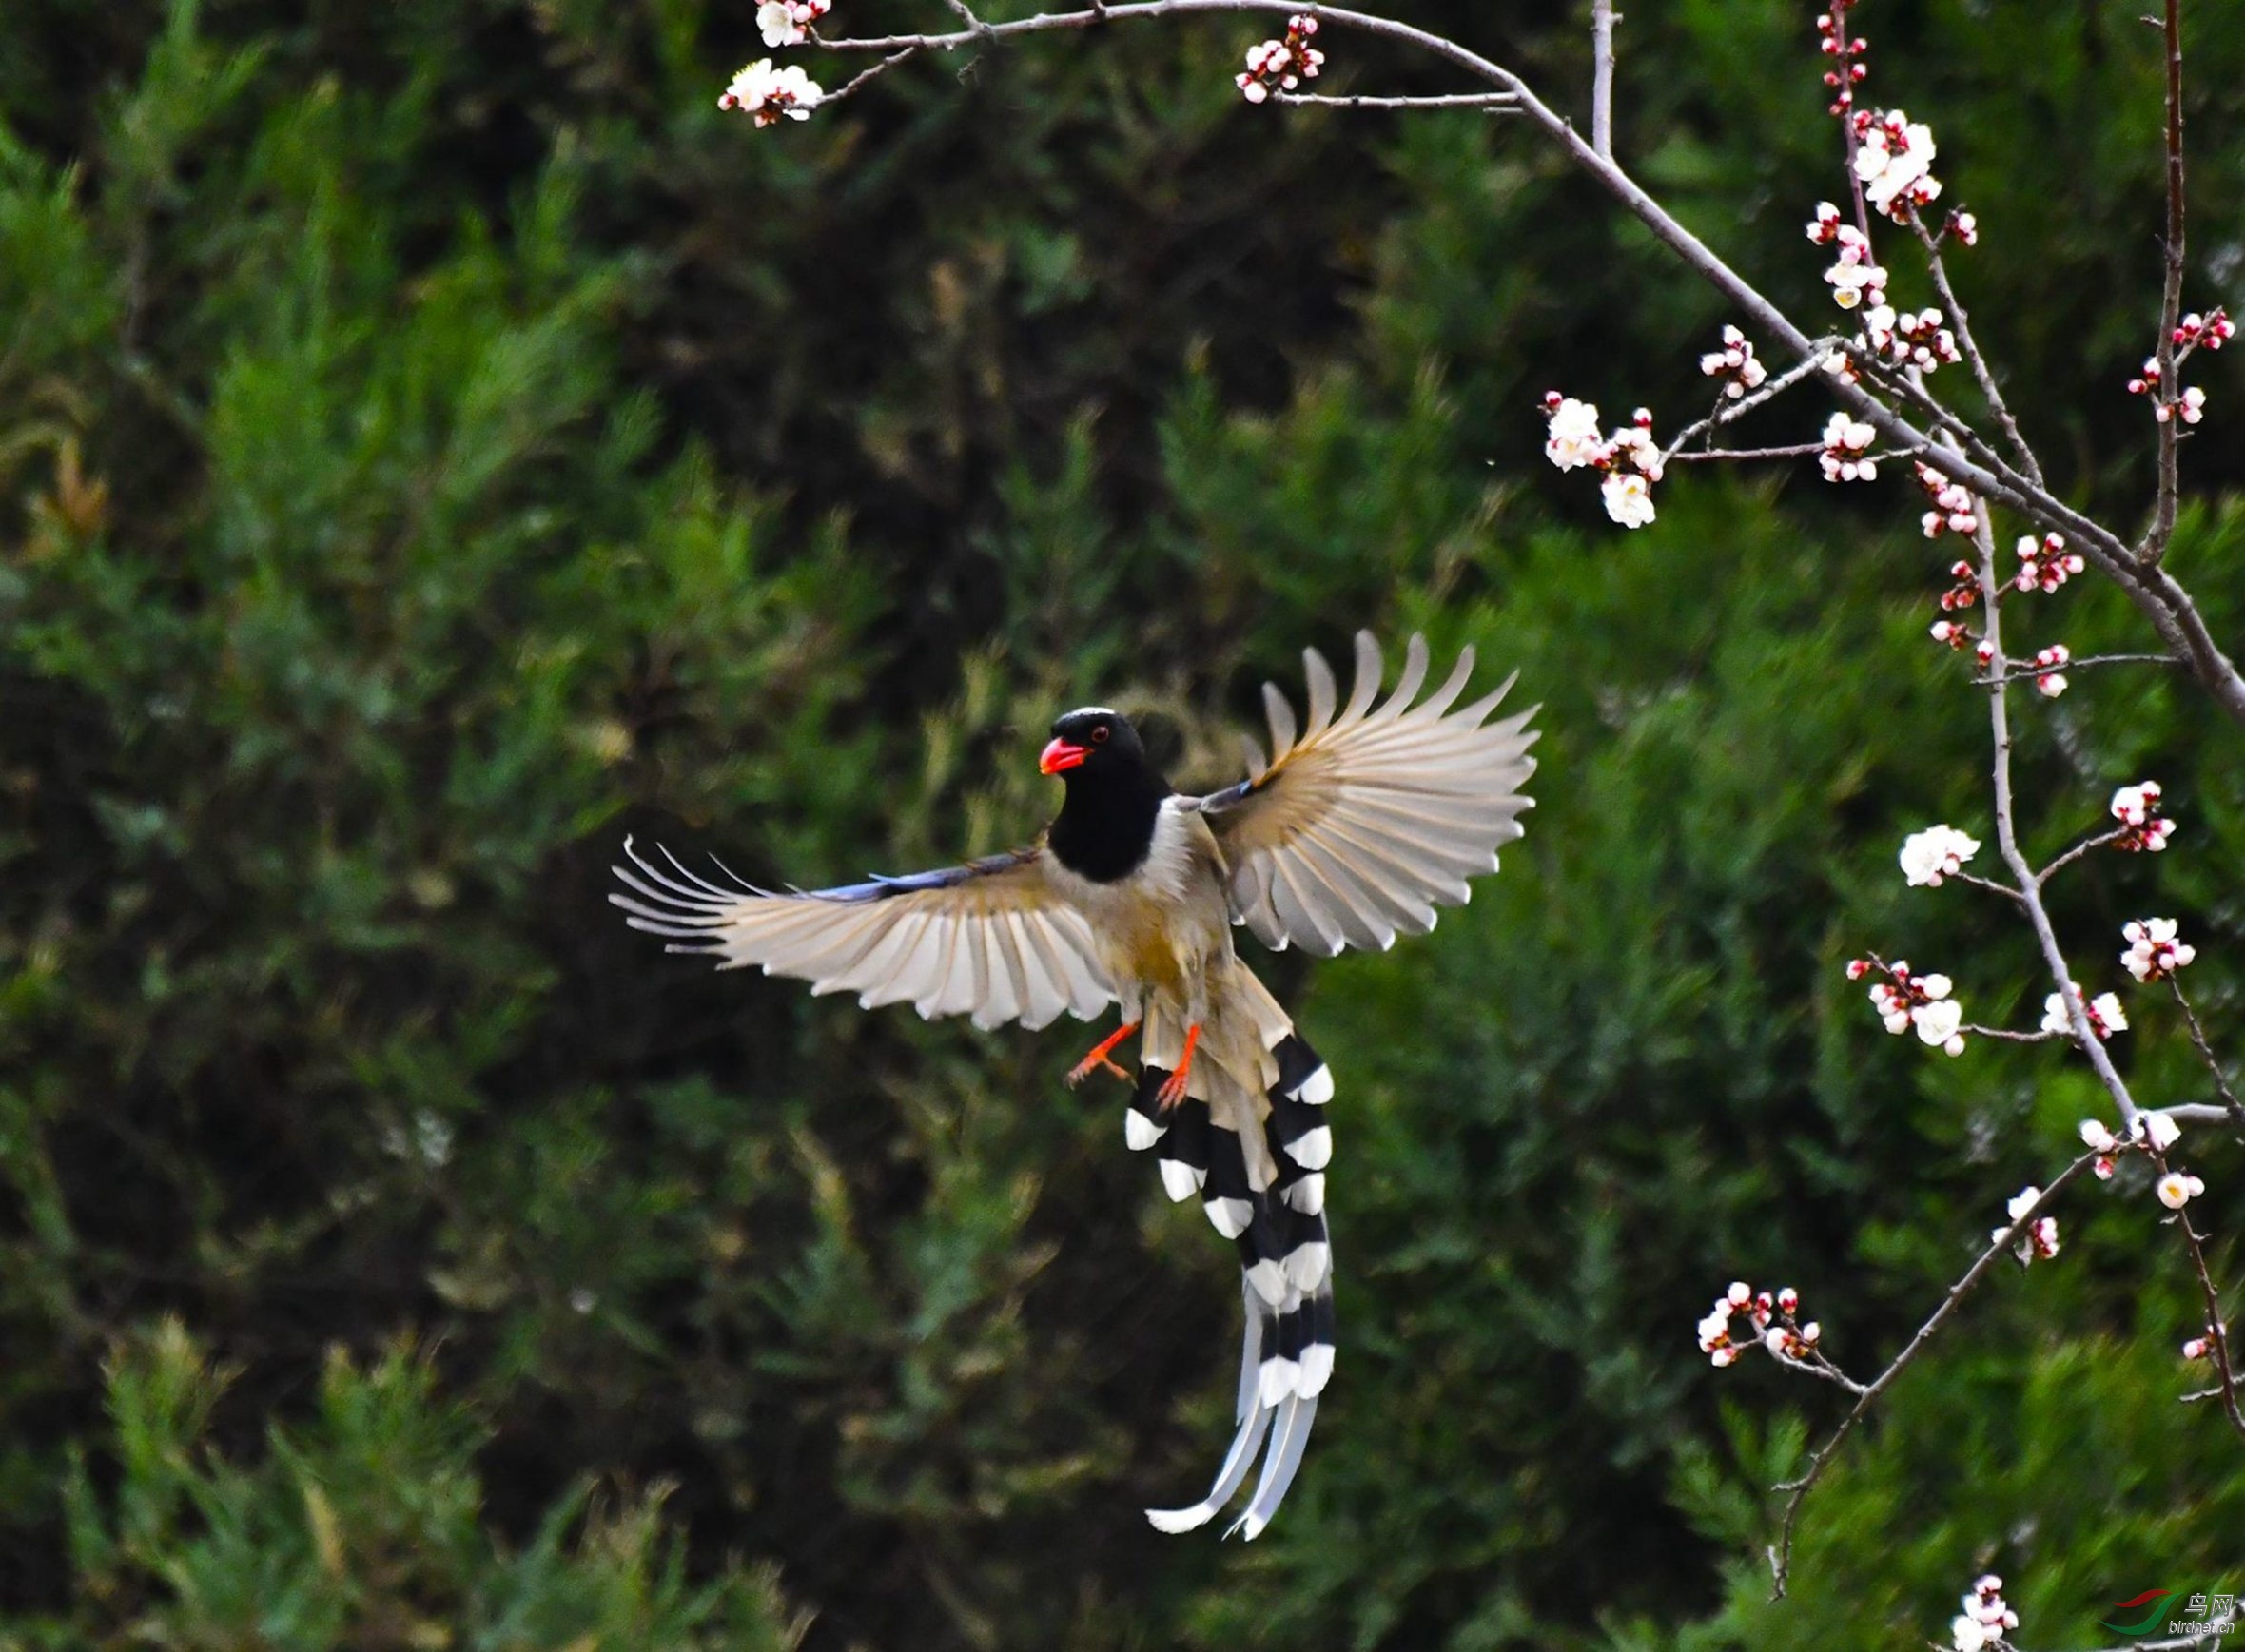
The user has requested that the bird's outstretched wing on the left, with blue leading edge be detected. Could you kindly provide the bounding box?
[609,837,1114,1028]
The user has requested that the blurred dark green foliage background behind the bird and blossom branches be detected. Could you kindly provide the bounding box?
[0,0,2245,1652]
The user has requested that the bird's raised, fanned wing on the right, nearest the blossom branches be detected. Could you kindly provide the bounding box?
[1201,631,1535,956]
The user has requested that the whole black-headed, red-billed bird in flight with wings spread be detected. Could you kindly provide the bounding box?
[609,631,1535,1538]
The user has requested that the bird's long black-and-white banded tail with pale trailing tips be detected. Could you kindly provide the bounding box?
[1124,1033,1334,1540]
